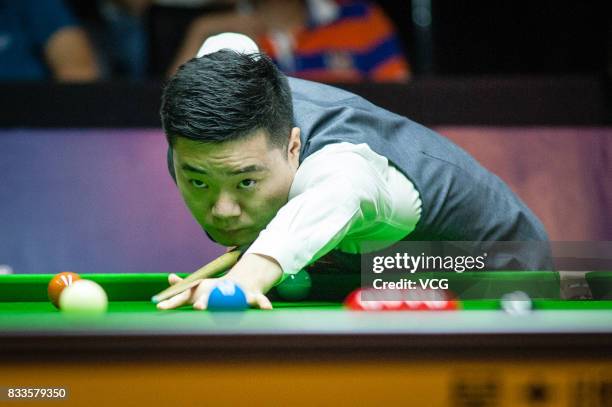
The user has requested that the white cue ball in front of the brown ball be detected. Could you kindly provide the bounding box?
[59,280,108,314]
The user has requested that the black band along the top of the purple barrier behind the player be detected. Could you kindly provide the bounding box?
[0,76,611,128]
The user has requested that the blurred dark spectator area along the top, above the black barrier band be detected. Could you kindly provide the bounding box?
[0,0,612,81]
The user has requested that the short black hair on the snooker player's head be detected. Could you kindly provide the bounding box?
[160,50,293,146]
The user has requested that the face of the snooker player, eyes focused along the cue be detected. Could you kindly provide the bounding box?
[173,128,300,246]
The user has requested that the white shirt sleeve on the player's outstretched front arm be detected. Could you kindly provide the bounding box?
[247,143,420,274]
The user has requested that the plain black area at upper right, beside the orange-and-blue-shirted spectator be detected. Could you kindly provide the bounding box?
[377,0,612,75]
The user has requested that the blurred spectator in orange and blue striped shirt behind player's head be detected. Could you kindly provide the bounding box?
[169,0,410,81]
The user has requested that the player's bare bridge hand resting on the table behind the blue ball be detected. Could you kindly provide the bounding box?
[157,254,282,310]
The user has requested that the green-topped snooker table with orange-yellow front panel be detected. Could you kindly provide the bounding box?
[0,272,612,406]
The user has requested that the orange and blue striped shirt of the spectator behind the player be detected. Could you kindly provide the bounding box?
[258,0,410,82]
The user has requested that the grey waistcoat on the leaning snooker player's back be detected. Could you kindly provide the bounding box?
[289,78,547,262]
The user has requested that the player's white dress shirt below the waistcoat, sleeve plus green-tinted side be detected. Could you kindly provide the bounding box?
[246,142,421,275]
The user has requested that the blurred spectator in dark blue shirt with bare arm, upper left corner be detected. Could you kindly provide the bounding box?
[0,0,99,82]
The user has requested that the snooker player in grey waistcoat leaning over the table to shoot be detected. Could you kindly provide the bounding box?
[158,33,547,309]
